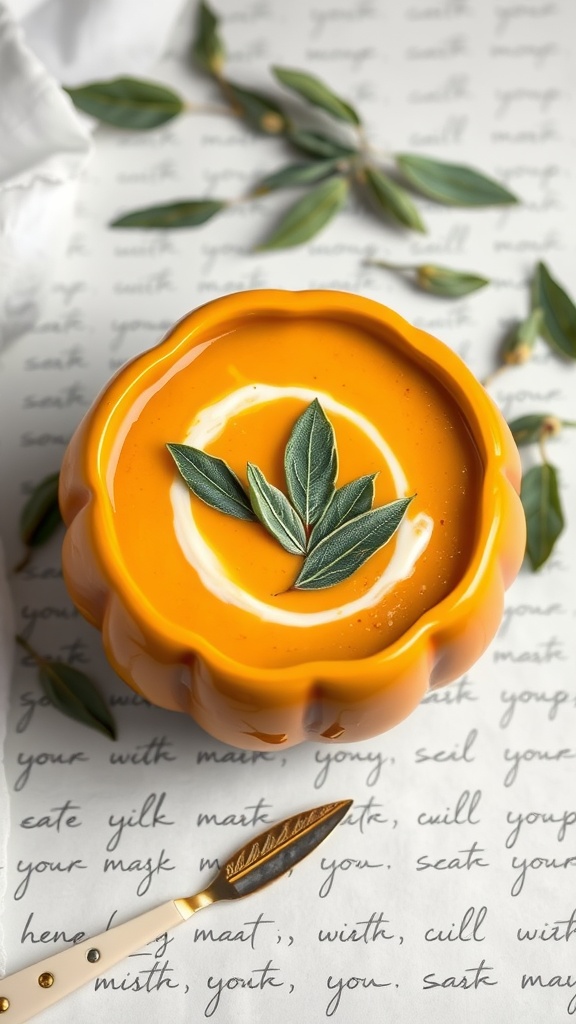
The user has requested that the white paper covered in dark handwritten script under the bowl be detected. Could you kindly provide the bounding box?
[0,0,576,1024]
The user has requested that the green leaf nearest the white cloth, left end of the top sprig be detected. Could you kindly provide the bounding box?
[66,78,184,131]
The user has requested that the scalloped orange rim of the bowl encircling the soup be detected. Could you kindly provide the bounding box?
[79,289,511,690]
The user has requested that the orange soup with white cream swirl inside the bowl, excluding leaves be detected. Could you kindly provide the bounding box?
[107,313,483,668]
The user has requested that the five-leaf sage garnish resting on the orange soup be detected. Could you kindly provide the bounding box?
[166,398,412,590]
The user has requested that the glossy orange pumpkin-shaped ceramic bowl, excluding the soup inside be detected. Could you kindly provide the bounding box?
[60,291,525,750]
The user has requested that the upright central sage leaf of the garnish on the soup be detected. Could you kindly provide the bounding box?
[284,398,338,526]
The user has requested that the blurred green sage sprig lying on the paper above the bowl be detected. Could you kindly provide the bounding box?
[62,0,517,243]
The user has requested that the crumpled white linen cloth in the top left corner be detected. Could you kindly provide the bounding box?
[0,0,184,350]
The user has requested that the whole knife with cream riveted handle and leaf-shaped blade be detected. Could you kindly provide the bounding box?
[0,800,353,1024]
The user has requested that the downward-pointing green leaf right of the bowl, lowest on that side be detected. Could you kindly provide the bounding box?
[520,463,564,569]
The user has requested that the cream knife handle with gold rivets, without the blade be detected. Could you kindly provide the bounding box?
[0,900,190,1024]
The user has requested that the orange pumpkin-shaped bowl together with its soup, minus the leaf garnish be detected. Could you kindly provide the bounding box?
[60,290,525,750]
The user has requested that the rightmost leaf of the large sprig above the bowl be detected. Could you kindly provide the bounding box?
[396,153,518,206]
